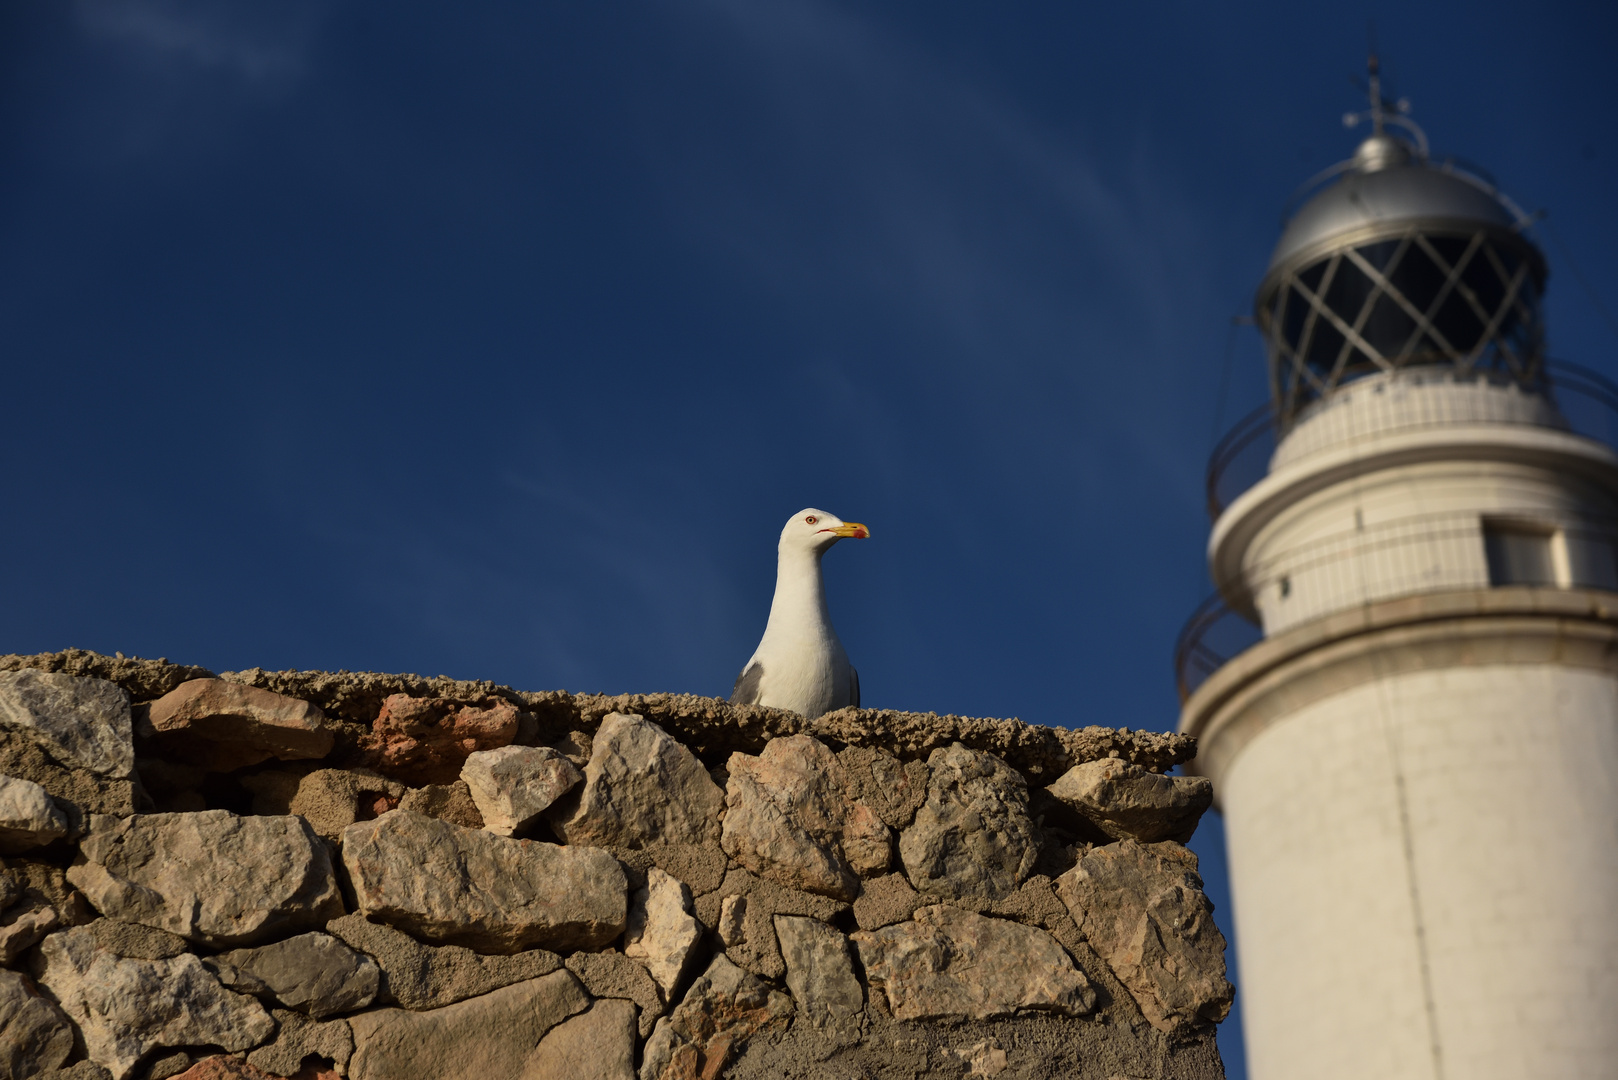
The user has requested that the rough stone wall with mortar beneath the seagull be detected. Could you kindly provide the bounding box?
[0,651,1231,1080]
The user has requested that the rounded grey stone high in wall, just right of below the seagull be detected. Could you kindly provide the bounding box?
[900,745,1039,900]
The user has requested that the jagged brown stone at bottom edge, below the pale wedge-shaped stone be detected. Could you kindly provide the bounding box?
[641,955,793,1080]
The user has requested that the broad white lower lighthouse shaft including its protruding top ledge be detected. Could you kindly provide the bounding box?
[1183,589,1618,1080]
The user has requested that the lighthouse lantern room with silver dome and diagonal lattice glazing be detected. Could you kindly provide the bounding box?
[1254,66,1545,432]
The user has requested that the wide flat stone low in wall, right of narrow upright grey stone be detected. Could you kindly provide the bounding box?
[853,904,1095,1020]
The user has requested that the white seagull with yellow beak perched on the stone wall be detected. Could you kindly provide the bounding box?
[730,507,870,719]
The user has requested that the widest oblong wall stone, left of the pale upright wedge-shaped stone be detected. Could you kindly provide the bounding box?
[343,810,629,952]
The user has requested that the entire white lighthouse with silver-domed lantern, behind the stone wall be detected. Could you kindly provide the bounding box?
[1180,62,1618,1080]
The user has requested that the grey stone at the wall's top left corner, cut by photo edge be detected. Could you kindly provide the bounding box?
[0,670,134,780]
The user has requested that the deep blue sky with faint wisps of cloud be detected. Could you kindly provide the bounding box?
[0,0,1618,1077]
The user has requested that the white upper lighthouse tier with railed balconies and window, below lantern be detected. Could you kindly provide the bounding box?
[1175,359,1618,699]
